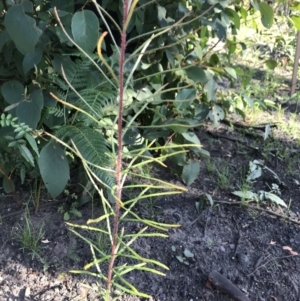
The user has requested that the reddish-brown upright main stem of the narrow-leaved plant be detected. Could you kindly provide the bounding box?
[107,0,129,296]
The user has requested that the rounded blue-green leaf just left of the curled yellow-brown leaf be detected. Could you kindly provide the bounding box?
[71,10,99,52]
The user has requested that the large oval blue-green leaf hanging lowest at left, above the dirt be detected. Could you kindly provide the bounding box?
[38,141,70,198]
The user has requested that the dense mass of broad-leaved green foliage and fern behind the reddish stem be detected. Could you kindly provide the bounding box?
[0,0,290,196]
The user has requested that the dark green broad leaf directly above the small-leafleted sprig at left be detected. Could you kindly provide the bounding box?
[16,89,44,129]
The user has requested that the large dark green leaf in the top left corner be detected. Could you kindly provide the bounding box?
[4,1,42,54]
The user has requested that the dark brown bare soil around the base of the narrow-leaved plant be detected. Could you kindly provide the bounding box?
[0,113,300,301]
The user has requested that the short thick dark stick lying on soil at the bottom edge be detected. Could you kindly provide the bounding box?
[208,271,250,301]
